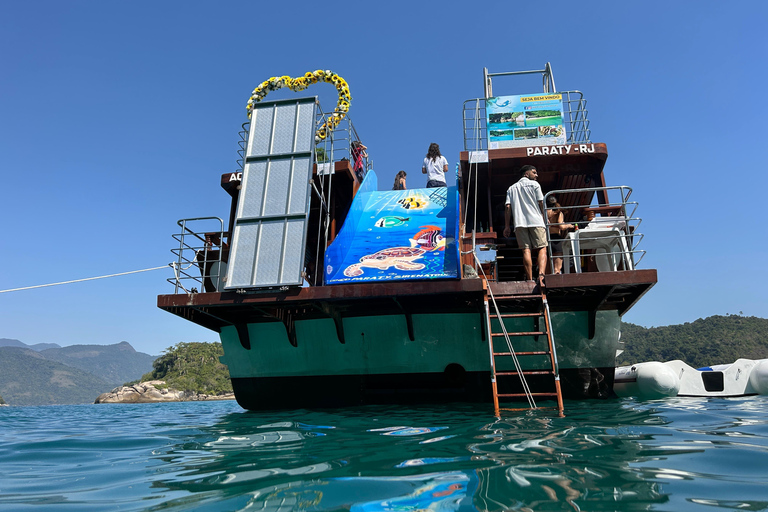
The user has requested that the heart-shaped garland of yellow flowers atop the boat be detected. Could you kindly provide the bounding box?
[245,69,352,142]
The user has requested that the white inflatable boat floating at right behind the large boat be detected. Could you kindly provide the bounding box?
[613,359,768,399]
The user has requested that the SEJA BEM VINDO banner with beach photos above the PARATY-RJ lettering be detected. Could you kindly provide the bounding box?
[485,93,566,149]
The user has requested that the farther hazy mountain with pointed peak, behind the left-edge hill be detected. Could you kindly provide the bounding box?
[40,341,155,386]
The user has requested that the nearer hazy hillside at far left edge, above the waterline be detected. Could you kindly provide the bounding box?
[0,347,111,405]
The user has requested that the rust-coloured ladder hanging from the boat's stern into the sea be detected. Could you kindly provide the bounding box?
[485,283,563,416]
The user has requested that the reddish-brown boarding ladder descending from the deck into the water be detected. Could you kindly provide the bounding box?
[485,281,563,416]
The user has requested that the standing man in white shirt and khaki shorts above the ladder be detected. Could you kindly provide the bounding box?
[504,165,547,281]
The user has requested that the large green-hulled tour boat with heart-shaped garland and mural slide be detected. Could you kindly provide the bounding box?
[157,63,657,412]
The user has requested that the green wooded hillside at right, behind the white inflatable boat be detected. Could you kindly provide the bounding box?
[617,315,768,368]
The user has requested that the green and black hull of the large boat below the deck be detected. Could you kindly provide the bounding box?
[221,311,621,409]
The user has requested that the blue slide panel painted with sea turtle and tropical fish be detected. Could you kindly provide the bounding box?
[325,171,459,284]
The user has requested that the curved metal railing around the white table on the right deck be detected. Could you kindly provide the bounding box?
[544,186,645,273]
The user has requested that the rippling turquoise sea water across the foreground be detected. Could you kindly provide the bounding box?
[0,397,768,512]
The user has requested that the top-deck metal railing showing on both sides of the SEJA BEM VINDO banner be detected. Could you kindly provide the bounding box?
[462,91,591,151]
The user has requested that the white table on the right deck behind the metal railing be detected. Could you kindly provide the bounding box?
[563,226,635,274]
